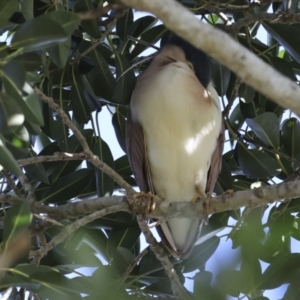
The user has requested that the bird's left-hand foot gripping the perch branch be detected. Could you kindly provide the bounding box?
[130,192,156,219]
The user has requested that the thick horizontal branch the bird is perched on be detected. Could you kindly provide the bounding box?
[29,180,300,220]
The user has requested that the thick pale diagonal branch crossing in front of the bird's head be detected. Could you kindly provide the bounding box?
[121,0,300,115]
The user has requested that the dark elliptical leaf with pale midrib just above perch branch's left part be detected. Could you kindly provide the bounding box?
[42,169,94,203]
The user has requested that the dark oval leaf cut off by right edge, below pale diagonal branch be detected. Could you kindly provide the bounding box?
[280,118,300,158]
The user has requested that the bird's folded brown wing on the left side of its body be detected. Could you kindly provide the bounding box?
[126,108,154,193]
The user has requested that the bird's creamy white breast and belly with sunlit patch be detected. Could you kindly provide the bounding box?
[131,62,221,201]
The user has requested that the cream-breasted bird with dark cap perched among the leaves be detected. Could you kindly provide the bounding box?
[126,34,224,259]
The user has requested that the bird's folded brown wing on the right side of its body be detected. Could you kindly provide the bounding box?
[205,122,225,195]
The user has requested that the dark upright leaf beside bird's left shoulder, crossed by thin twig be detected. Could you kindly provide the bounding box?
[113,53,136,104]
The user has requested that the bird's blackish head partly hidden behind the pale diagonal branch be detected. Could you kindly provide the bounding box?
[163,34,211,88]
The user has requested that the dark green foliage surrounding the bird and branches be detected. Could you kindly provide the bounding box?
[0,0,300,300]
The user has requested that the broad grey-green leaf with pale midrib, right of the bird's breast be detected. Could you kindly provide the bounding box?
[246,112,279,149]
